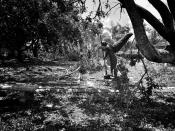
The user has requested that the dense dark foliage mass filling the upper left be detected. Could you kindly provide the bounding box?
[0,0,87,59]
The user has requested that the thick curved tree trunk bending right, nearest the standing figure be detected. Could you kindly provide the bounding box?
[119,0,175,64]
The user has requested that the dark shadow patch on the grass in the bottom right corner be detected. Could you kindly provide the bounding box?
[125,97,175,129]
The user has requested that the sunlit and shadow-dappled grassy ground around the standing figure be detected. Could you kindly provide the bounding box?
[0,58,175,131]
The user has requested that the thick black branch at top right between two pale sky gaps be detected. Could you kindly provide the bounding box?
[148,0,174,32]
